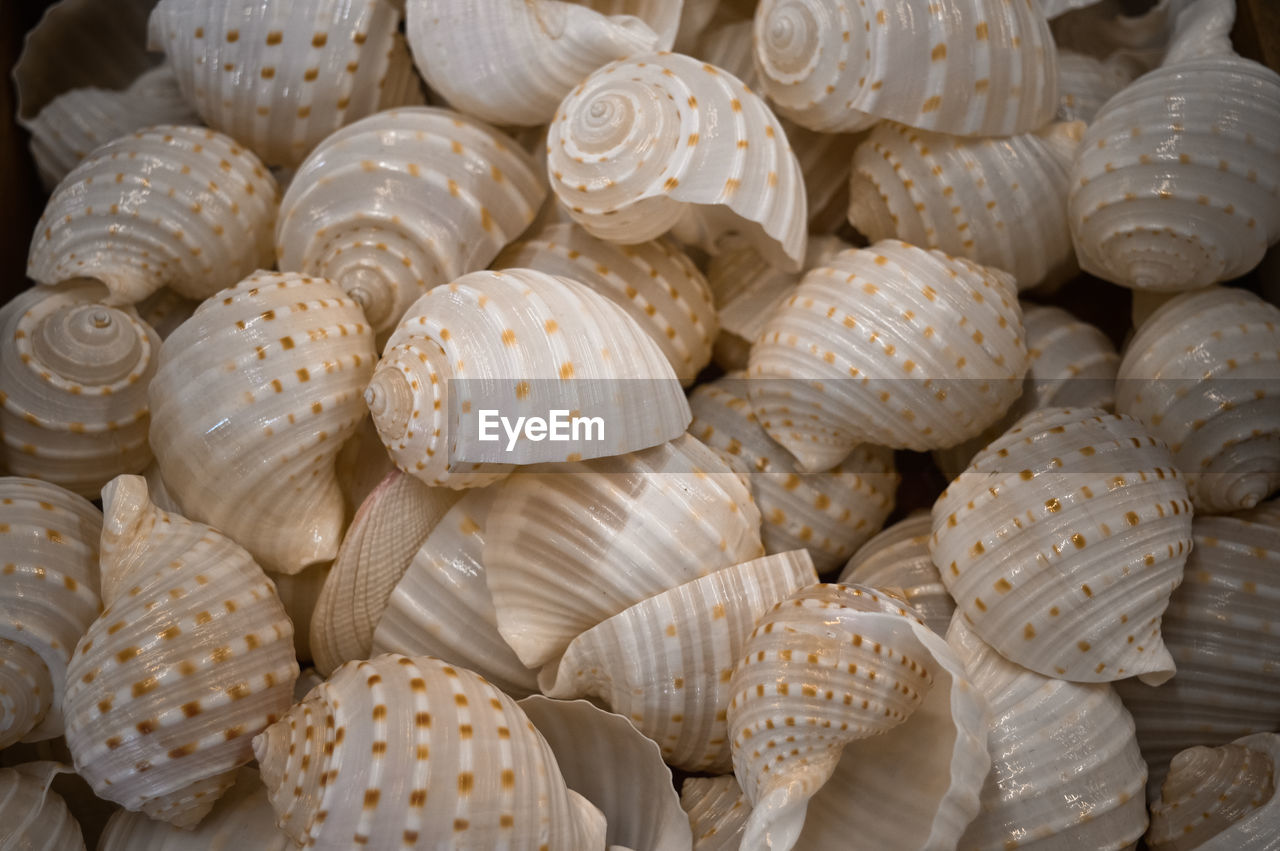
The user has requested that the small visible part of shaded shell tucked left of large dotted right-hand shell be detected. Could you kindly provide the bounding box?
[840,512,956,635]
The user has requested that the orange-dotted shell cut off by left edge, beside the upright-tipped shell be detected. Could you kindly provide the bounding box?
[0,477,102,747]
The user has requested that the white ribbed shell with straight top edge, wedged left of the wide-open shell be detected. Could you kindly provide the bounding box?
[538,550,818,773]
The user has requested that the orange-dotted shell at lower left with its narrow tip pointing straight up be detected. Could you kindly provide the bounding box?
[63,476,298,828]
